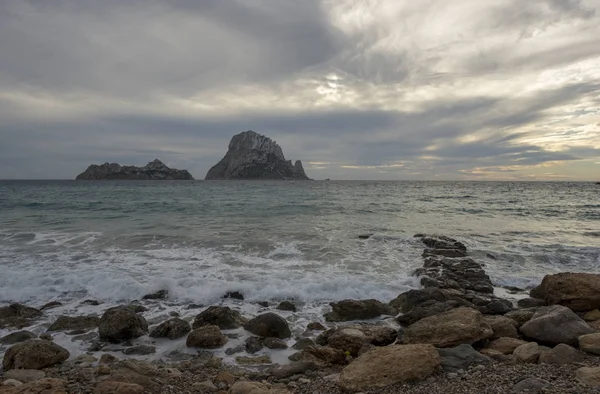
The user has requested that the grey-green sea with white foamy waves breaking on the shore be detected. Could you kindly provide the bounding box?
[0,181,600,358]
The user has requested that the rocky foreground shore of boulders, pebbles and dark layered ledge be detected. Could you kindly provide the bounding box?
[0,234,600,394]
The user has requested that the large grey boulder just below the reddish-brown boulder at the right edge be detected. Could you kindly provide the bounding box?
[520,305,594,345]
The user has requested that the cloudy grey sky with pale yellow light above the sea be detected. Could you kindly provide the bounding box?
[0,0,600,181]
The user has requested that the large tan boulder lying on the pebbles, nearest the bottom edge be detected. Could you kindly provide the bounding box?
[339,345,440,392]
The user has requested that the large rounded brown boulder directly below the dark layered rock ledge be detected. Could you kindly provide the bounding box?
[402,307,493,347]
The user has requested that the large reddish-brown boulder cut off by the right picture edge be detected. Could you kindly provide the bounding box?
[531,272,600,312]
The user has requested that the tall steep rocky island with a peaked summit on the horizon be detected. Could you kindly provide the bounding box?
[206,131,309,180]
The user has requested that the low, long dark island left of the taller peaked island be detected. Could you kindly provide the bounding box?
[75,159,194,181]
